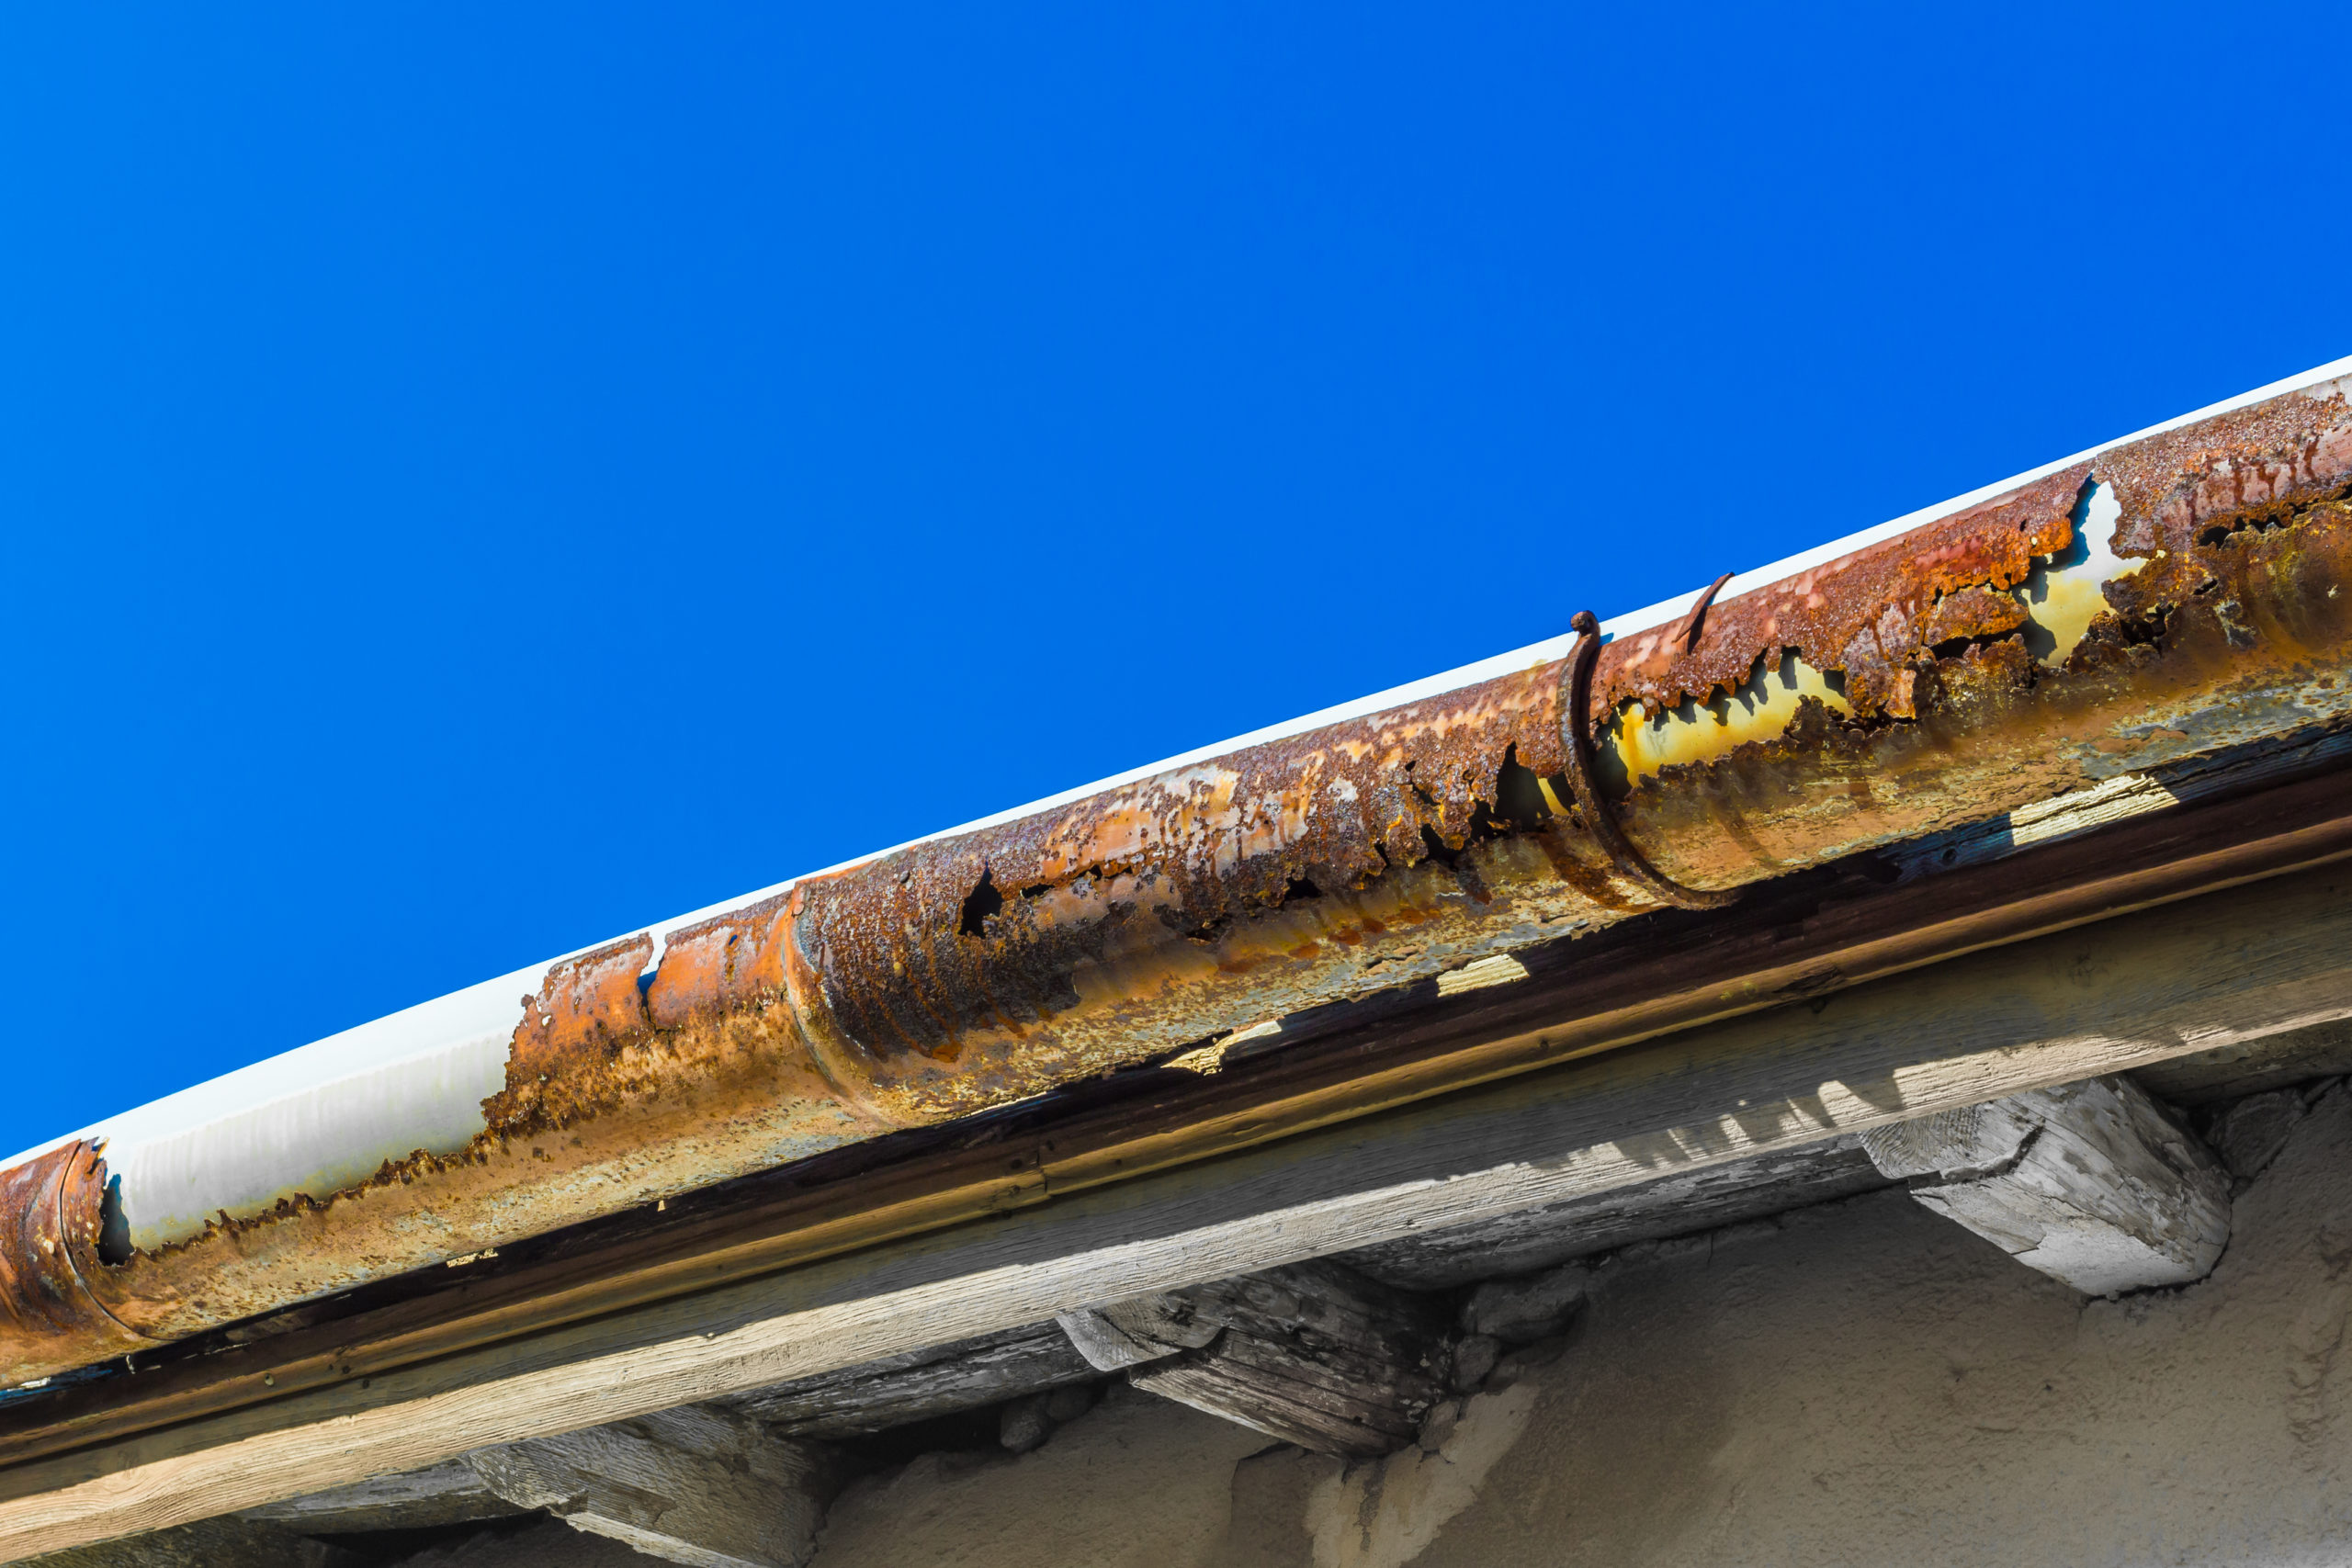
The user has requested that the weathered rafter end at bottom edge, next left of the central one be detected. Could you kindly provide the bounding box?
[466,1405,837,1568]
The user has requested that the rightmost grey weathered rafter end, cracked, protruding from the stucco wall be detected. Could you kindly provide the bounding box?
[1863,1077,2230,1295]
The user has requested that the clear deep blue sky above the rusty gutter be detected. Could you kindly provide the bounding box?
[0,3,2352,1155]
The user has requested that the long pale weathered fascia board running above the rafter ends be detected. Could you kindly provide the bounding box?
[0,865,2352,1554]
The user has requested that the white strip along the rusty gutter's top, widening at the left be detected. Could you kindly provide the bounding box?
[0,355,2352,1190]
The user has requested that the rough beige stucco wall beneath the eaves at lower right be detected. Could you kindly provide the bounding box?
[816,1090,2352,1568]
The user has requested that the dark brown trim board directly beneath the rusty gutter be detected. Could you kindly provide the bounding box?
[0,761,2352,1464]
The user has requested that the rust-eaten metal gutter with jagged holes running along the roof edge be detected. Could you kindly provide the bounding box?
[0,365,2352,1382]
